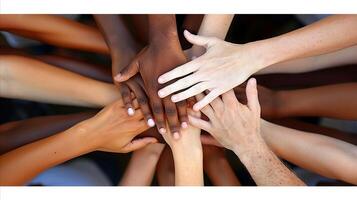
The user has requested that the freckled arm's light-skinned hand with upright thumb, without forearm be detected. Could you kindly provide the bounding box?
[189,78,260,152]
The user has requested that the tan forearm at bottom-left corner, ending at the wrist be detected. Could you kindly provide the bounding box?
[0,123,93,185]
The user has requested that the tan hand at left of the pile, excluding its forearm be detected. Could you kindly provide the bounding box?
[80,101,157,153]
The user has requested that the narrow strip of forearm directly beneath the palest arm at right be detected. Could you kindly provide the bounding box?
[257,46,357,74]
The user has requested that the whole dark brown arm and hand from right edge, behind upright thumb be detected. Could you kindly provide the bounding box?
[235,83,357,120]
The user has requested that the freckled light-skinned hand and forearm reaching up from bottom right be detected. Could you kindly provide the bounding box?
[189,79,305,186]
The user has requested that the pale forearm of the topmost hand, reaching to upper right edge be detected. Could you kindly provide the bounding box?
[250,15,357,70]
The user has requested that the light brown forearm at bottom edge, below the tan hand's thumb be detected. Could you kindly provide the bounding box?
[118,144,165,186]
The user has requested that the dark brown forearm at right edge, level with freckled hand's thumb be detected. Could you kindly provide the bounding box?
[277,83,357,120]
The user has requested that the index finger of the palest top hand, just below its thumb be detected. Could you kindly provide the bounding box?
[158,59,199,84]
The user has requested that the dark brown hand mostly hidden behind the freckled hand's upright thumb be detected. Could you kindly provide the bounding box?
[234,84,281,119]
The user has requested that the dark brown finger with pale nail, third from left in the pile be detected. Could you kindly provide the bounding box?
[149,92,166,134]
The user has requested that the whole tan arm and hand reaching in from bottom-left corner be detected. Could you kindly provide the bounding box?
[0,101,157,185]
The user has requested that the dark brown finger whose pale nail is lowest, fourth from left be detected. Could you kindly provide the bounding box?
[163,97,180,139]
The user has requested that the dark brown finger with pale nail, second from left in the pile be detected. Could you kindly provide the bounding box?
[128,82,155,127]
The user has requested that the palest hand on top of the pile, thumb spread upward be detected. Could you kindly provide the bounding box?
[158,31,262,111]
